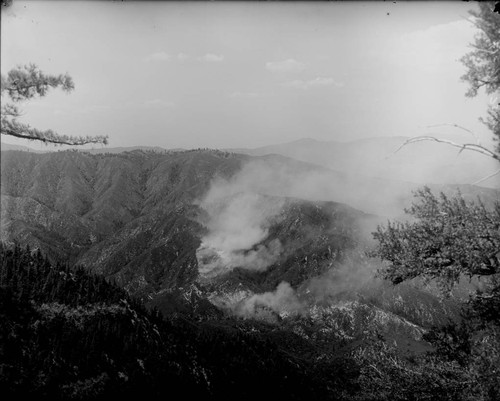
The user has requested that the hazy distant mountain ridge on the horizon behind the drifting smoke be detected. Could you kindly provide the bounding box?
[228,136,500,188]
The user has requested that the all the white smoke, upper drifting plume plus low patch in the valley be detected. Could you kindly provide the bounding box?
[193,156,490,317]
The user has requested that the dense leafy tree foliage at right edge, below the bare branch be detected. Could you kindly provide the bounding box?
[372,187,500,289]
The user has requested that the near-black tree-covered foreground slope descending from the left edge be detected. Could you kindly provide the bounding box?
[0,246,356,400]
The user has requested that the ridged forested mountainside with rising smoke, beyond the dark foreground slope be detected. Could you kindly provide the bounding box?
[1,150,490,337]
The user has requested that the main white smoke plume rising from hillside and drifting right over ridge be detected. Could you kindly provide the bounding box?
[197,158,388,278]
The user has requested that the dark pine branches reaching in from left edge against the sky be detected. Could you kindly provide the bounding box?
[0,64,108,145]
